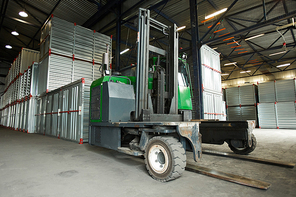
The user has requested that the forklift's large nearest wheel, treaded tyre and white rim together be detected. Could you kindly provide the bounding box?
[145,136,186,182]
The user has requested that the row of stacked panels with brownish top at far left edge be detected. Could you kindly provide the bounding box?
[1,48,39,131]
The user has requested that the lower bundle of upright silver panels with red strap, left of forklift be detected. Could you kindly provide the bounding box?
[36,79,89,143]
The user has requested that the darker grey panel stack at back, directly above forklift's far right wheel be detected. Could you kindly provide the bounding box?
[225,84,257,124]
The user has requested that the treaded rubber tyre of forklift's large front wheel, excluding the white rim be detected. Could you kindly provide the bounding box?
[145,136,186,182]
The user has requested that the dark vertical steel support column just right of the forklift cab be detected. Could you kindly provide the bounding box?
[189,0,204,119]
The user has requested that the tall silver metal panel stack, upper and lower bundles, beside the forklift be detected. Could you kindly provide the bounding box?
[36,17,112,142]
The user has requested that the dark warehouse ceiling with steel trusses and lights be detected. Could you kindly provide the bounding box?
[0,0,296,80]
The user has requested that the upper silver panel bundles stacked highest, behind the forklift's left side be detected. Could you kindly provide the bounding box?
[38,17,112,94]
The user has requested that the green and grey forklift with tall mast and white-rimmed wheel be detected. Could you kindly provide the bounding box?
[89,8,255,182]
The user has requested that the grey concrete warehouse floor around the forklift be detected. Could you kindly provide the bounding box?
[0,127,296,197]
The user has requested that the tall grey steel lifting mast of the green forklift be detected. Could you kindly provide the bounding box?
[134,9,179,121]
